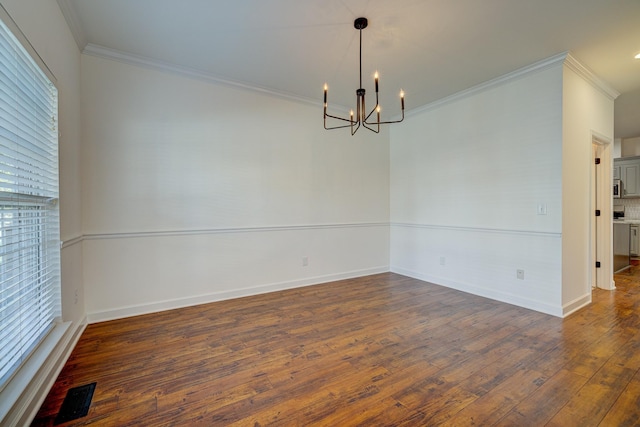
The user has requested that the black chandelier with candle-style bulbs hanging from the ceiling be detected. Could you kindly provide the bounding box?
[324,18,404,135]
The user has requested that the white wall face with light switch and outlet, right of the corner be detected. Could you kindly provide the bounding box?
[391,61,562,315]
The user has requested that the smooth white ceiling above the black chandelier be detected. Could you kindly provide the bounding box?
[58,0,640,138]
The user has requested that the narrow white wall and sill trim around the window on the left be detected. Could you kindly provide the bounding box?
[0,0,86,426]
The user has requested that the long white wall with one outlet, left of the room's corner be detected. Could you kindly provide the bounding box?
[82,55,389,321]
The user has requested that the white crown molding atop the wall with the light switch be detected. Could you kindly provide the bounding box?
[405,52,568,117]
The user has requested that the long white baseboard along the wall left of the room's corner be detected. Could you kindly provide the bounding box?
[87,265,389,323]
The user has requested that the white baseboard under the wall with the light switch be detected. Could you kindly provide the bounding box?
[390,265,563,317]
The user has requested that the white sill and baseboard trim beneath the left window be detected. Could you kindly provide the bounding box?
[0,317,87,427]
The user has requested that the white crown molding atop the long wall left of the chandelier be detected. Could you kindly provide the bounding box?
[82,43,323,107]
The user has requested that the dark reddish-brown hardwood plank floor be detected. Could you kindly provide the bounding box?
[33,267,640,427]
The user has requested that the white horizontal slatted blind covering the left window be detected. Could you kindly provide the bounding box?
[0,15,60,390]
